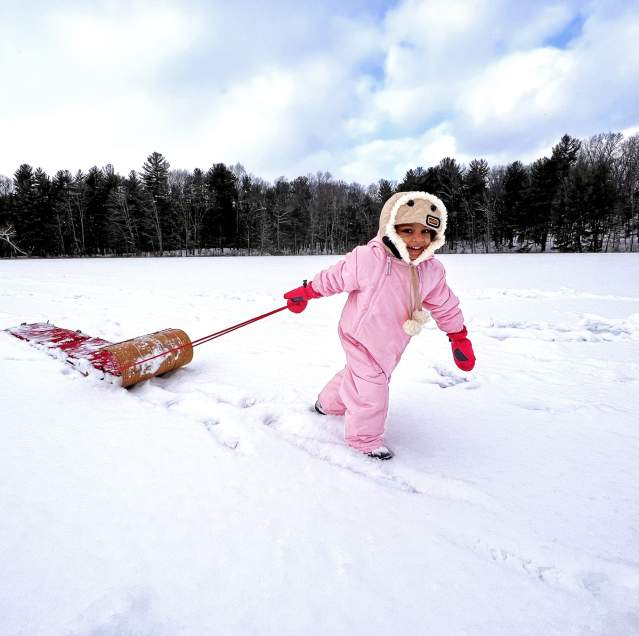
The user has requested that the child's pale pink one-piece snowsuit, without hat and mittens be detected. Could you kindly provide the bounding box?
[312,238,464,453]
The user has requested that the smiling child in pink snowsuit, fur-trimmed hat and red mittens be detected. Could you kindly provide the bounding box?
[284,192,475,459]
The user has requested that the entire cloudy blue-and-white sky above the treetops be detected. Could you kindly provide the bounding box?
[0,0,639,185]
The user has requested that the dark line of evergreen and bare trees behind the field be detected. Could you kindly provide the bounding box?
[0,133,639,257]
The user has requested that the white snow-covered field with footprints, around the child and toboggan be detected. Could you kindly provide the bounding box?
[0,254,639,636]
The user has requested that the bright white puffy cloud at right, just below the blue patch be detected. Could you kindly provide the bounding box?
[453,3,639,161]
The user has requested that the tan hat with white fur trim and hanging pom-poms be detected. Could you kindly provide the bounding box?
[378,192,448,336]
